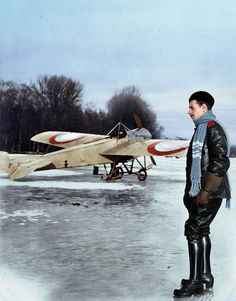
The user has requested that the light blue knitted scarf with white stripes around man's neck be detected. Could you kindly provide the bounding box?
[189,110,231,207]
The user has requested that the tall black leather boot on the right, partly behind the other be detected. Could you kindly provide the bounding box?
[202,235,214,289]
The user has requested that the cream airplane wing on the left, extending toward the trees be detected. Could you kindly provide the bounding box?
[31,131,110,148]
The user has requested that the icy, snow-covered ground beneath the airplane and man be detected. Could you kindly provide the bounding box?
[0,158,236,301]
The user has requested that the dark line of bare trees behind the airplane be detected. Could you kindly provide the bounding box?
[0,76,163,152]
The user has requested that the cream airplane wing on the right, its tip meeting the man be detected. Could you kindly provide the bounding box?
[101,139,189,158]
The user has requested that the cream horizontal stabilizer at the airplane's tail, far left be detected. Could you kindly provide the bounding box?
[8,158,52,179]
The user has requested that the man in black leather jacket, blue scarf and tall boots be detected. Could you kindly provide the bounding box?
[174,91,230,297]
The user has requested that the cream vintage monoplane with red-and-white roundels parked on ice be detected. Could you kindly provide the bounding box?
[0,122,189,181]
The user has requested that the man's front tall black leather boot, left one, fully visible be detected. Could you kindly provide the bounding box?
[174,240,203,298]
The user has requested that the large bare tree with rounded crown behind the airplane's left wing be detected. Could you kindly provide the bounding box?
[34,75,83,130]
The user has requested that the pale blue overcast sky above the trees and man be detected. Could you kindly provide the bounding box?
[0,0,236,144]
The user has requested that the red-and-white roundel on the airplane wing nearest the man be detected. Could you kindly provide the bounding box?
[148,141,188,156]
